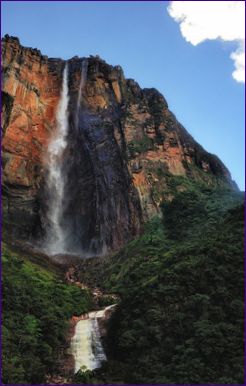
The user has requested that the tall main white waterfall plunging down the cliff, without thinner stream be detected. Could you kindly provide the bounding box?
[46,63,69,253]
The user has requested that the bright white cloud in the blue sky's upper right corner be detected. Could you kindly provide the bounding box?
[168,1,245,83]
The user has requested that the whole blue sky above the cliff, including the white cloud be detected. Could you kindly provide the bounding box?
[1,1,245,190]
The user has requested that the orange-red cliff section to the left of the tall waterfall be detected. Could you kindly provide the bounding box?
[2,38,62,241]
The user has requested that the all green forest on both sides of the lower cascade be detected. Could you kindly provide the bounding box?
[2,181,244,384]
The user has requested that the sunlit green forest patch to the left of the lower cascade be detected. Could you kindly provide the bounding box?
[2,245,91,384]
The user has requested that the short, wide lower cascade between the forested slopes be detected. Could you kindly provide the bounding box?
[69,305,115,373]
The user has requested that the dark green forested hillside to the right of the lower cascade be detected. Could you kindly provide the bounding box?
[72,185,244,384]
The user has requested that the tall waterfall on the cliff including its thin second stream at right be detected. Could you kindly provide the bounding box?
[46,60,88,254]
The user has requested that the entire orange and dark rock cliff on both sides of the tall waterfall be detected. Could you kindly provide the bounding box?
[2,36,234,252]
